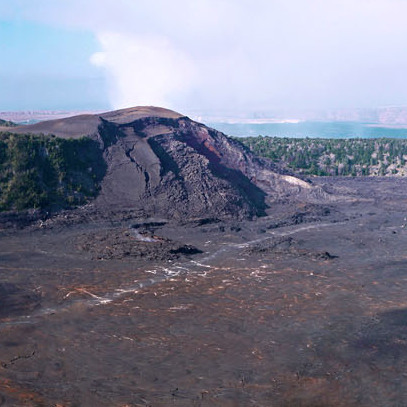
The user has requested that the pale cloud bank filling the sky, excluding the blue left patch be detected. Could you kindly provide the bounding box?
[0,0,407,110]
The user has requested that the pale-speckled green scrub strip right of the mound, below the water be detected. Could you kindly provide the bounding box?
[238,136,407,176]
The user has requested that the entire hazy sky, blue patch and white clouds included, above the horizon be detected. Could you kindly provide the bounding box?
[0,0,407,112]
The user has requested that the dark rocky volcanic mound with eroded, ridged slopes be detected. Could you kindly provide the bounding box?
[7,107,332,219]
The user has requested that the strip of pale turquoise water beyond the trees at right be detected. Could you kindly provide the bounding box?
[206,122,407,138]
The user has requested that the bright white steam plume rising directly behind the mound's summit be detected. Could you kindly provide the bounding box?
[91,32,198,108]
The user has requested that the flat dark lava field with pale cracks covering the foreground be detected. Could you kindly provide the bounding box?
[0,178,407,407]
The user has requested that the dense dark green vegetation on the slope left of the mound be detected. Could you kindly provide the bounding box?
[0,132,105,211]
